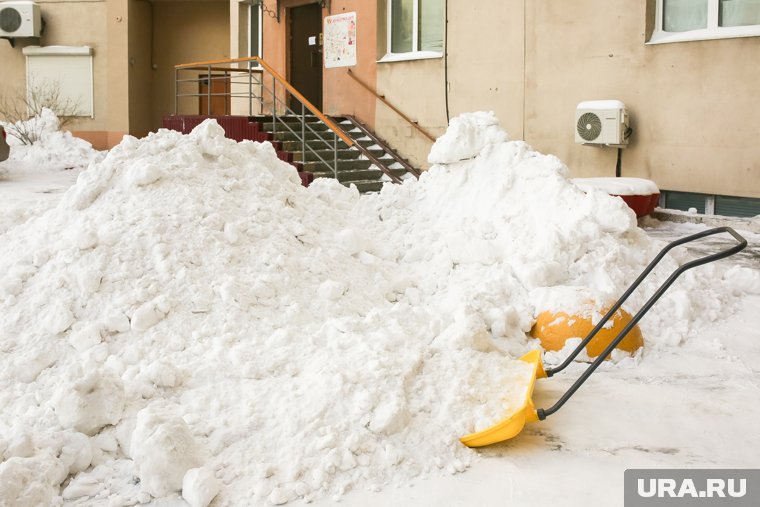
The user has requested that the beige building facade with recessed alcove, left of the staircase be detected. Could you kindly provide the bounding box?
[0,0,230,149]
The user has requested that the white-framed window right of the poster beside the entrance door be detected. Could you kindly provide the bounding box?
[383,0,444,61]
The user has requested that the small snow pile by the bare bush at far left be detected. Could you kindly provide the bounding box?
[3,108,104,171]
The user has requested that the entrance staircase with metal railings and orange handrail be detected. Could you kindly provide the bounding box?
[163,57,420,192]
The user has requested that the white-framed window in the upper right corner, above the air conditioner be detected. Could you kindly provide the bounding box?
[649,0,760,44]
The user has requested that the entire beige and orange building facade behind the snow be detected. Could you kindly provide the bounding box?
[0,0,760,213]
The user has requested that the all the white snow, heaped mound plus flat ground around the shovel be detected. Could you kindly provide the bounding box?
[0,113,760,506]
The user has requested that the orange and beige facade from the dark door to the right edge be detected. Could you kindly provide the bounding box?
[231,0,760,212]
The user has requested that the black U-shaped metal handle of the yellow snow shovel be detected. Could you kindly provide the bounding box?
[536,227,747,420]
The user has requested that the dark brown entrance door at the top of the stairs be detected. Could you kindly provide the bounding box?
[288,3,322,110]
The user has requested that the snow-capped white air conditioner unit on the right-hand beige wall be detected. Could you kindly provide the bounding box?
[575,100,630,147]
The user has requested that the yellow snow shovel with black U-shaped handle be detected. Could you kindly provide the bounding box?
[459,227,747,447]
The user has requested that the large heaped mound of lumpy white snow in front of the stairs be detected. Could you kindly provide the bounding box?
[0,115,756,505]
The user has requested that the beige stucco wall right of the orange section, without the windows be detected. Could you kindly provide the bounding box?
[366,0,760,197]
